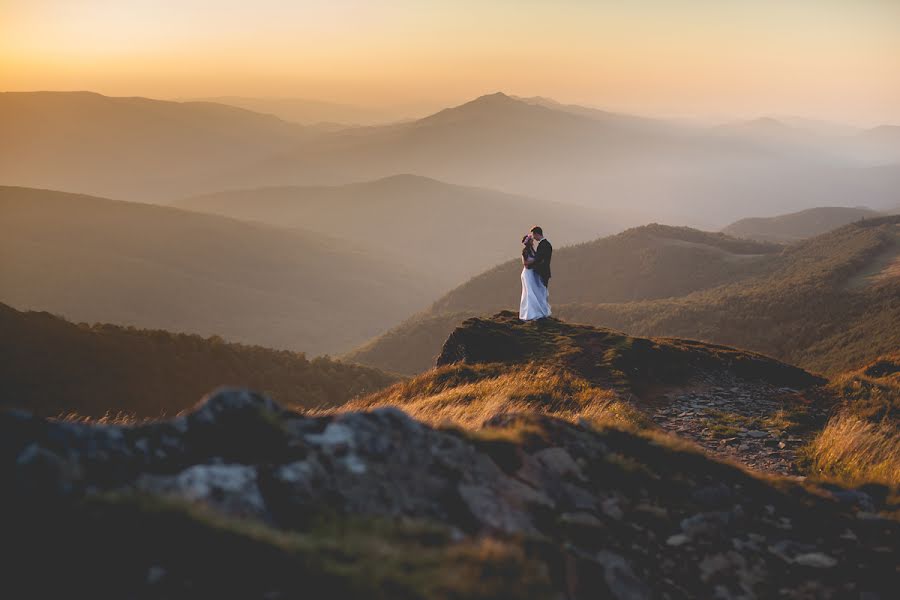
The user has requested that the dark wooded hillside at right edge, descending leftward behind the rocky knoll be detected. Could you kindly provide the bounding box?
[559,217,900,373]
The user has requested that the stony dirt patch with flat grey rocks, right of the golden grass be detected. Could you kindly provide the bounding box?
[650,381,827,475]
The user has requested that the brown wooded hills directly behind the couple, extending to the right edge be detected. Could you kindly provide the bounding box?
[347,216,900,373]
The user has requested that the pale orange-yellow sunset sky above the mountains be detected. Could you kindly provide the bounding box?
[0,0,900,125]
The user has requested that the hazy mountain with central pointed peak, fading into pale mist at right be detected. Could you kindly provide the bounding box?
[225,93,893,227]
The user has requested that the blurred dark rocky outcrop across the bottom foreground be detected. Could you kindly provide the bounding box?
[0,389,900,599]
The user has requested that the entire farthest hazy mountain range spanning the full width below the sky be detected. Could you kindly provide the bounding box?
[7,92,900,228]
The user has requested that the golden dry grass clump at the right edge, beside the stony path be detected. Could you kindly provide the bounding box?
[806,413,900,488]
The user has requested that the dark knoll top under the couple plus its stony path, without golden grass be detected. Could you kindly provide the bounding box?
[437,312,831,475]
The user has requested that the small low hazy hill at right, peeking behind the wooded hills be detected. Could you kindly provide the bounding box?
[722,206,882,242]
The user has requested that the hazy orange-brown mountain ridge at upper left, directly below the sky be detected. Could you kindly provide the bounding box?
[0,92,310,200]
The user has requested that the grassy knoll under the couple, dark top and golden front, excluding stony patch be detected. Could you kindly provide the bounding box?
[336,312,821,427]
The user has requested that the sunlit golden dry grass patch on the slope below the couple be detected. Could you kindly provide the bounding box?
[332,364,649,429]
